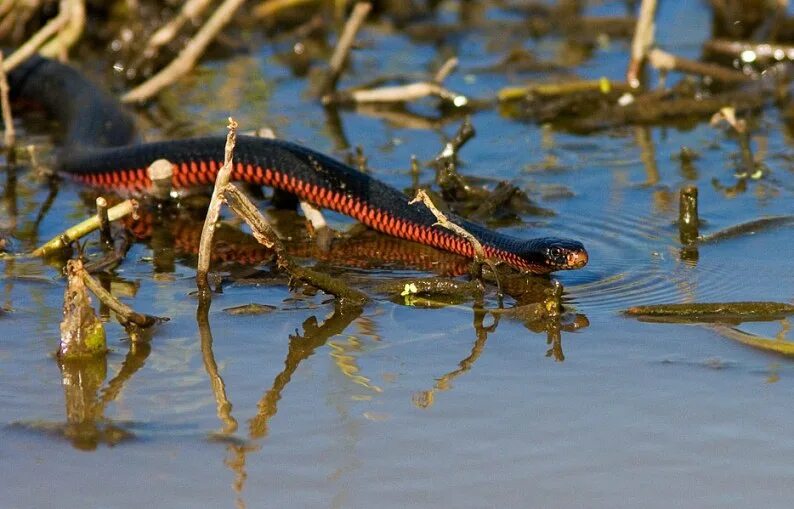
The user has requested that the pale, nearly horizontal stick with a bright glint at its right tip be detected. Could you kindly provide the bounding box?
[322,81,469,108]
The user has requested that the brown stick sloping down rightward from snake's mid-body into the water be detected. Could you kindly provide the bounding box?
[221,184,368,306]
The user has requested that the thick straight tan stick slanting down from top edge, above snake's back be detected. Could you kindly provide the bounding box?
[121,0,245,103]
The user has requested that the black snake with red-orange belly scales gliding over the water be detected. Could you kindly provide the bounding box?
[8,56,588,274]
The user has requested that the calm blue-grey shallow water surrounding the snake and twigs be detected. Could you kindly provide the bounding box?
[0,2,794,508]
